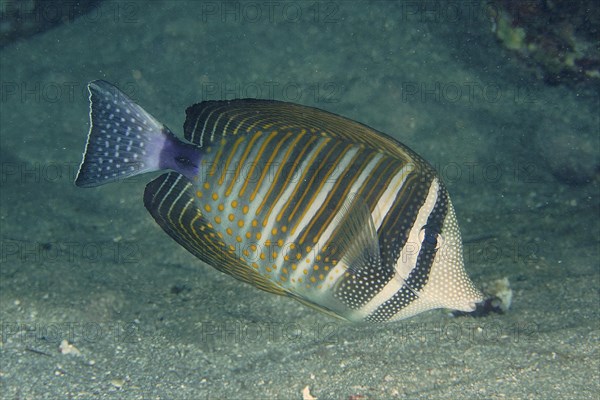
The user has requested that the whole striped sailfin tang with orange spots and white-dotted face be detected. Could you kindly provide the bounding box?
[75,81,482,322]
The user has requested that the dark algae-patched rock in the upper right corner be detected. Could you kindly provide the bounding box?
[487,0,600,85]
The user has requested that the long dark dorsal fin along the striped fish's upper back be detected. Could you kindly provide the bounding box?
[183,99,421,160]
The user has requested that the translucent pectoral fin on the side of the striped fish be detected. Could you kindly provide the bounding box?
[331,194,381,273]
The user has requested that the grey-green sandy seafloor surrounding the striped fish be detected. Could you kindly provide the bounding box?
[0,1,600,399]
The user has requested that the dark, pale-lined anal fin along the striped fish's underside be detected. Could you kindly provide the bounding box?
[144,172,286,294]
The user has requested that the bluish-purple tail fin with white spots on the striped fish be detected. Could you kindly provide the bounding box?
[75,80,175,187]
